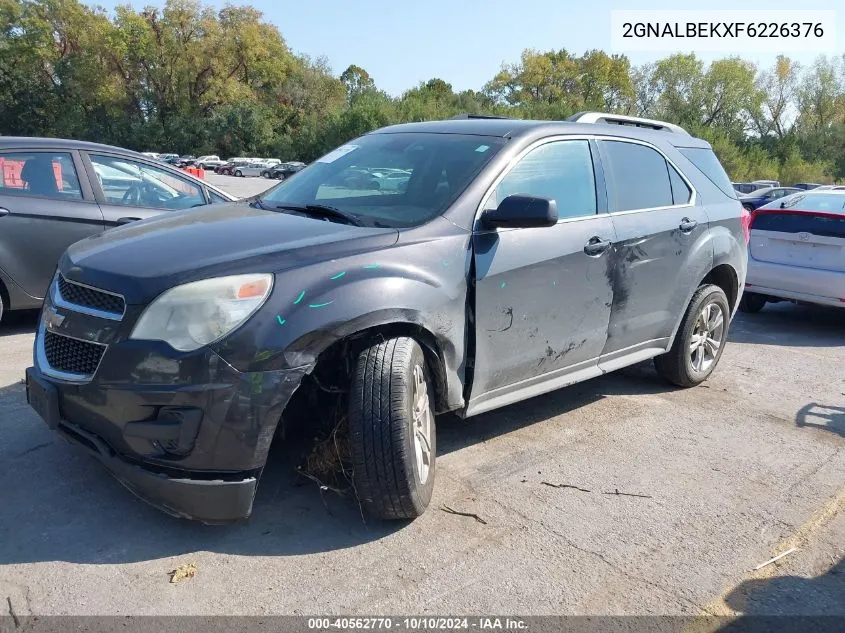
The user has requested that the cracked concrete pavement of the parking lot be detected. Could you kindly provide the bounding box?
[0,176,845,616]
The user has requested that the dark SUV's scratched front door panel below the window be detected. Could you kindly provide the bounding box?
[471,215,613,400]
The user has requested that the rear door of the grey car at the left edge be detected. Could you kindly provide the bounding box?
[0,149,105,299]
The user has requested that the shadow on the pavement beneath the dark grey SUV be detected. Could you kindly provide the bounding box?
[0,363,671,564]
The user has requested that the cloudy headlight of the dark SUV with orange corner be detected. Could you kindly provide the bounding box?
[129,275,273,352]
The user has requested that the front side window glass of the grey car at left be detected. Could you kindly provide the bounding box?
[91,154,206,210]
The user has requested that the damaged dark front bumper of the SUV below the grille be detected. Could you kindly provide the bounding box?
[26,326,306,523]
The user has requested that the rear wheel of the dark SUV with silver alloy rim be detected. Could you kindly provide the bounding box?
[654,284,731,387]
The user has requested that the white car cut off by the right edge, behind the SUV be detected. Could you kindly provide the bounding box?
[740,189,845,312]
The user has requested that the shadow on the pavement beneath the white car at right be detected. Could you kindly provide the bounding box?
[729,303,845,347]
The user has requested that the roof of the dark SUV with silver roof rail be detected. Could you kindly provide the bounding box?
[371,113,710,148]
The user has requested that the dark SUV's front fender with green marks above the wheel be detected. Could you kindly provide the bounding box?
[218,218,471,406]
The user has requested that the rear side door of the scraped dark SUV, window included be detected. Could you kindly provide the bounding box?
[598,139,712,371]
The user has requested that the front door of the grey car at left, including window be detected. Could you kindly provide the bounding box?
[85,152,208,227]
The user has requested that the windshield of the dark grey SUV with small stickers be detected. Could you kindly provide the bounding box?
[261,132,505,228]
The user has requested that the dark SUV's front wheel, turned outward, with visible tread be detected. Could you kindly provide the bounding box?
[349,337,437,519]
